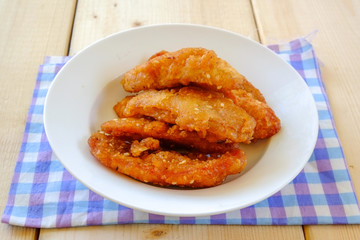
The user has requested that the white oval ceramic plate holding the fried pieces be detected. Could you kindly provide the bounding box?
[44,24,318,216]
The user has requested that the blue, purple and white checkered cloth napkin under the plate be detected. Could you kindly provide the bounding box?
[2,38,360,228]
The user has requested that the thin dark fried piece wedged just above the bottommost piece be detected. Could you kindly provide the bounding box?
[101,118,237,155]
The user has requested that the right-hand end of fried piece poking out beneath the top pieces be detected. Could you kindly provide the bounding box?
[228,90,281,141]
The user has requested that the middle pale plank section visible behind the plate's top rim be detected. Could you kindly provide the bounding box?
[70,0,258,55]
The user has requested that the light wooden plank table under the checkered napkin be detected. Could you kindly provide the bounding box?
[0,0,360,239]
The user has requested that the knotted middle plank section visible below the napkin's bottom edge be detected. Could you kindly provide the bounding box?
[39,224,304,240]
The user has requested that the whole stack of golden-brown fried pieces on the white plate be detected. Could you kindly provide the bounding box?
[89,48,280,188]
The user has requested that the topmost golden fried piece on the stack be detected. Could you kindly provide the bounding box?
[121,48,265,102]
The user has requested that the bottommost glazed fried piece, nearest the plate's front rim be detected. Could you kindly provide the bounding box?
[88,132,247,188]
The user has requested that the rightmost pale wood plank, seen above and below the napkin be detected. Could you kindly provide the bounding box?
[253,0,360,239]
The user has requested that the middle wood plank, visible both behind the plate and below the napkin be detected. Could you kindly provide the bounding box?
[40,0,304,239]
